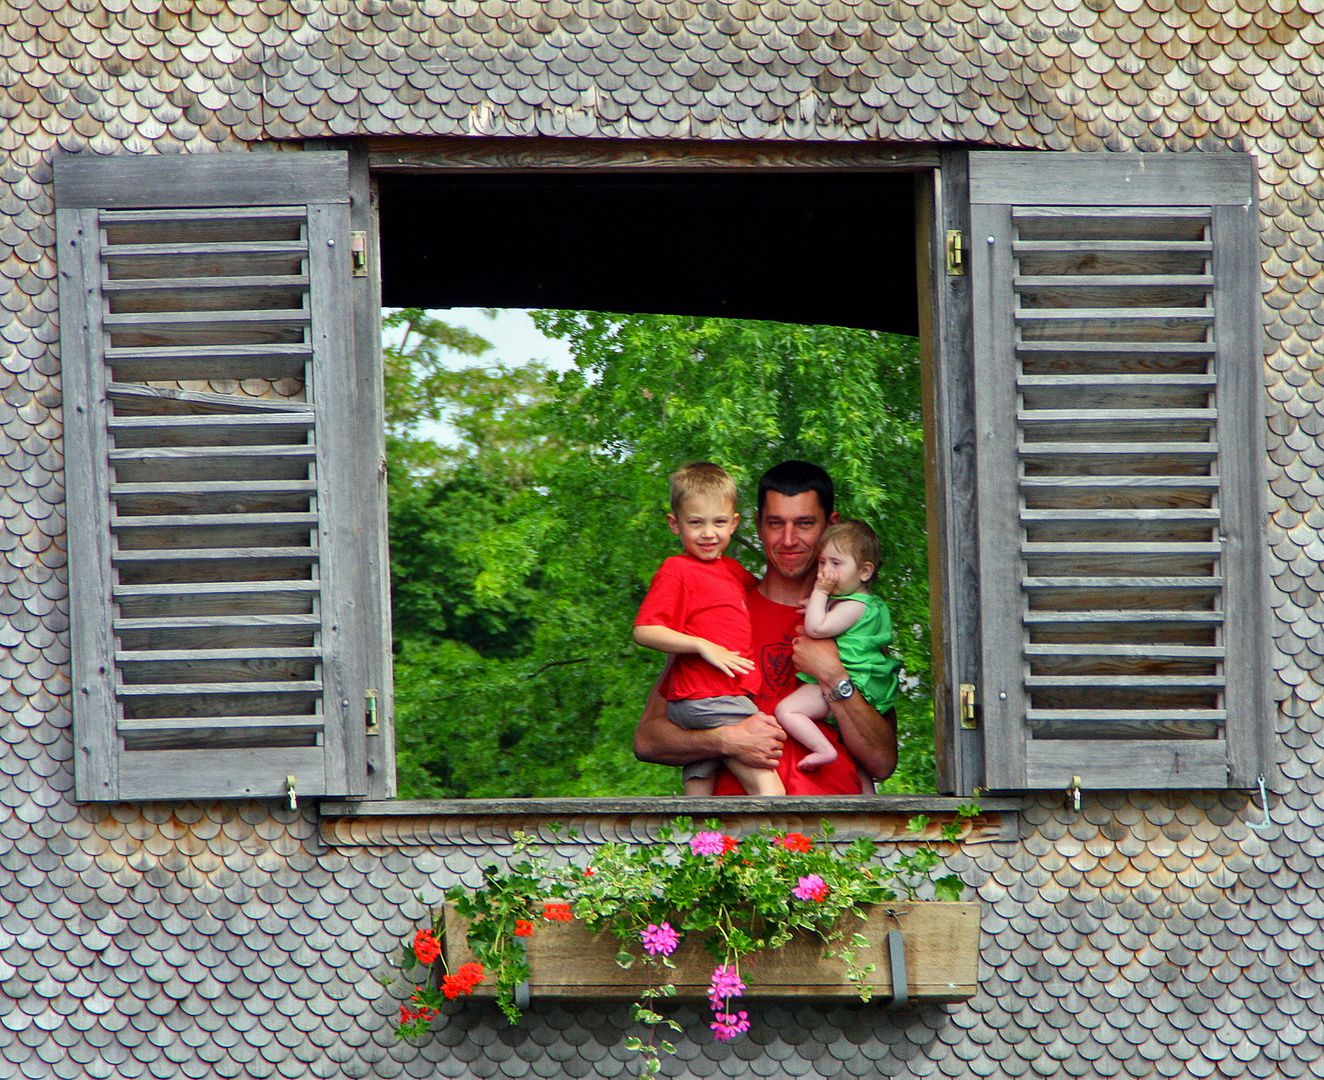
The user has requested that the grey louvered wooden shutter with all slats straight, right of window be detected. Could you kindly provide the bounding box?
[970,152,1272,789]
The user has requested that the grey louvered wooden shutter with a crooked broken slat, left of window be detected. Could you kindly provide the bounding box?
[56,152,387,801]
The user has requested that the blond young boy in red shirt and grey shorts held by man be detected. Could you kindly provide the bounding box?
[634,462,785,795]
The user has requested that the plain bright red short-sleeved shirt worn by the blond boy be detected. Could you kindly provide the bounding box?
[634,553,759,701]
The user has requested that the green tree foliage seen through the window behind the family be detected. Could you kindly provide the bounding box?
[388,311,933,798]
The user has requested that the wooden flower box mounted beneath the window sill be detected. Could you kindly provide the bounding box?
[445,901,980,1002]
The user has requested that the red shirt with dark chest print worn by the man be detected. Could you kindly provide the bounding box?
[714,585,859,795]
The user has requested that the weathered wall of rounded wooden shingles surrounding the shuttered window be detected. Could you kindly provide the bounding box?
[0,0,1324,1077]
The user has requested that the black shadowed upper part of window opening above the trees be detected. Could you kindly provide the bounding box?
[380,172,919,335]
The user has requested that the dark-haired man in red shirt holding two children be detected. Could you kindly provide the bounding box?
[634,461,896,795]
